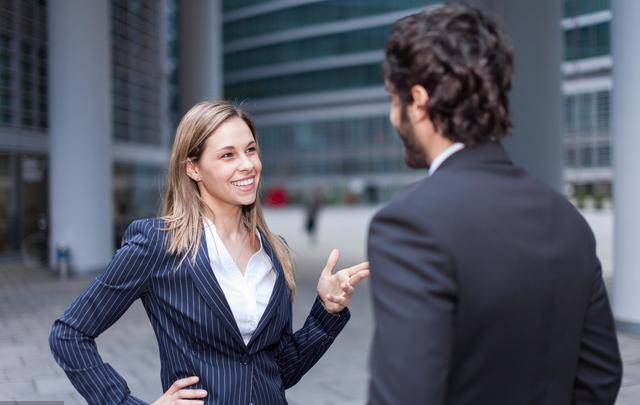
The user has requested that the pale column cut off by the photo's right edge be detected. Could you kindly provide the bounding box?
[611,0,640,333]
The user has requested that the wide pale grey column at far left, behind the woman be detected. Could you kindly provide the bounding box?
[47,0,113,272]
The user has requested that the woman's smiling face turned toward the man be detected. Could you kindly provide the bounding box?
[187,117,262,209]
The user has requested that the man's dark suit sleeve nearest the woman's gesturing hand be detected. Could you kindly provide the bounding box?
[368,208,457,405]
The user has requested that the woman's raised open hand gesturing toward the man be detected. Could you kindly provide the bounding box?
[318,249,369,314]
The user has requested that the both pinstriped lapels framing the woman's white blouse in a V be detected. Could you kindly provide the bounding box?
[185,223,285,347]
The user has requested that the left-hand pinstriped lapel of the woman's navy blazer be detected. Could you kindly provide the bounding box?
[185,226,244,346]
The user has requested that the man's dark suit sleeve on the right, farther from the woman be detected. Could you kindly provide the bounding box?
[572,259,622,405]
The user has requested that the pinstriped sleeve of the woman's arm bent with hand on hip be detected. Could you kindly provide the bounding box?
[49,219,161,405]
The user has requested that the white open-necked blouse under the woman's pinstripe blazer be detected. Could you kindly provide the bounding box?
[204,218,276,344]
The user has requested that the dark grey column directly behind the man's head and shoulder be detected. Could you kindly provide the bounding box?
[466,0,563,191]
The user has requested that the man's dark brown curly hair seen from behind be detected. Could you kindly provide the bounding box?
[384,5,513,145]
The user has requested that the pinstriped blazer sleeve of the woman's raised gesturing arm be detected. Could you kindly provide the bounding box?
[277,297,351,389]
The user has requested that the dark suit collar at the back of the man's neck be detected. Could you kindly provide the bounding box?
[433,142,513,176]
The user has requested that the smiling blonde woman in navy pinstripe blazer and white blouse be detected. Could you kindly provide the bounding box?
[50,102,369,405]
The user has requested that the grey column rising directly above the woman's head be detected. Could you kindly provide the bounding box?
[179,0,223,113]
